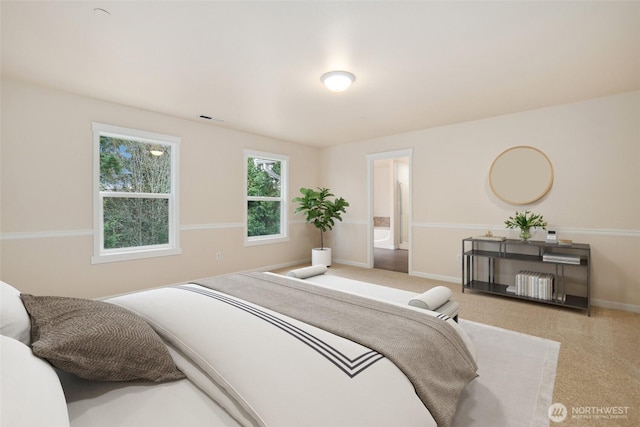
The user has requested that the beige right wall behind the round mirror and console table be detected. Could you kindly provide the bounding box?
[322,92,640,311]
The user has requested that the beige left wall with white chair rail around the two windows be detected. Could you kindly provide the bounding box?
[0,80,319,297]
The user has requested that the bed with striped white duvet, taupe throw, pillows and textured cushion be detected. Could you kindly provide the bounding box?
[0,273,477,427]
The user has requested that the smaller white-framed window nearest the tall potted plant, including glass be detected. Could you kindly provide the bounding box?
[244,151,289,245]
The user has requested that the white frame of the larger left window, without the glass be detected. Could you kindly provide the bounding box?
[91,122,182,264]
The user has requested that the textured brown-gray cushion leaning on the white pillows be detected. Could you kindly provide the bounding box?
[20,294,184,382]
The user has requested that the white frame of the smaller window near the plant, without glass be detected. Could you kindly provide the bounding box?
[243,150,289,246]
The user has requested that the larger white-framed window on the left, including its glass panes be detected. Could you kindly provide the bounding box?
[92,123,181,263]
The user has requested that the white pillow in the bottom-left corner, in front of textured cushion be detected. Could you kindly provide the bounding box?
[0,336,69,427]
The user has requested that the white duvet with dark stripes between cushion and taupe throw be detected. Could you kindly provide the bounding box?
[109,285,436,427]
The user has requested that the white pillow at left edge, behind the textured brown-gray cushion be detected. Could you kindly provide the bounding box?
[0,282,31,345]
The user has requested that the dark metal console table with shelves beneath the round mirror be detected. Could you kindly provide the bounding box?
[462,237,591,315]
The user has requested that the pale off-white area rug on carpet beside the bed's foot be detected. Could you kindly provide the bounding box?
[452,319,560,427]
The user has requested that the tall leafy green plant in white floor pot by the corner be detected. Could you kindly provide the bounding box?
[291,187,349,267]
